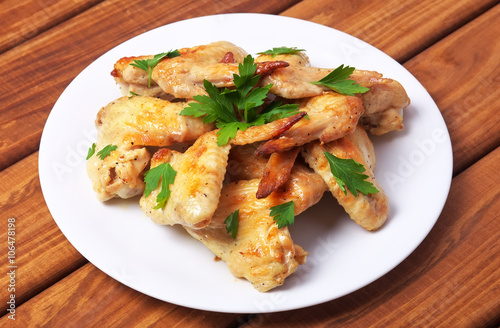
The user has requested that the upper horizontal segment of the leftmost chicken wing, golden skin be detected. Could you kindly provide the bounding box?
[96,96,214,147]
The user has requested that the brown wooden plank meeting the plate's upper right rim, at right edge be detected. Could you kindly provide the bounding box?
[405,6,500,173]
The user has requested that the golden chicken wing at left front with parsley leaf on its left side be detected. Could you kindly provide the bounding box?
[140,130,231,229]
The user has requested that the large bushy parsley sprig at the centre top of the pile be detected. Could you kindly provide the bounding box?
[180,55,299,146]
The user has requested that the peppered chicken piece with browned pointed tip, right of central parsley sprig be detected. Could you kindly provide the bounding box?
[257,92,363,155]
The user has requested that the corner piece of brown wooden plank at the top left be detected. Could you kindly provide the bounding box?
[0,0,102,53]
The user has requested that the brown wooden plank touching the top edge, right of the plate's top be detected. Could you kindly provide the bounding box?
[282,0,497,63]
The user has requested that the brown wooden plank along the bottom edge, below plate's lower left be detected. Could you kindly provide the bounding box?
[0,263,246,328]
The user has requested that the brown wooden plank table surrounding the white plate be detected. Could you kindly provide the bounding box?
[0,0,500,327]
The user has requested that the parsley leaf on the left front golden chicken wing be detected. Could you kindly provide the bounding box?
[144,163,177,210]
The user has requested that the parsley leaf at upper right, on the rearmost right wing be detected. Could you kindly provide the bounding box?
[311,64,370,96]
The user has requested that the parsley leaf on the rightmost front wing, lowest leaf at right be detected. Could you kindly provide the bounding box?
[324,151,379,197]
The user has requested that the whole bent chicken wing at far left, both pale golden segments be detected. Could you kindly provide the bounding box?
[87,96,214,201]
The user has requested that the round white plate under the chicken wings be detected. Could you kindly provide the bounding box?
[39,14,452,313]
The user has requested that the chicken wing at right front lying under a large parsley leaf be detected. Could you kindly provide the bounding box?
[302,127,389,230]
